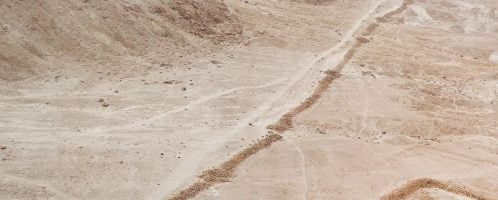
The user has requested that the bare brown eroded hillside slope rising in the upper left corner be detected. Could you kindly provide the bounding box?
[0,0,242,81]
